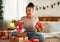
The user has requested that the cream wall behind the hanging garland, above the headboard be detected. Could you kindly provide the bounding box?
[27,0,60,16]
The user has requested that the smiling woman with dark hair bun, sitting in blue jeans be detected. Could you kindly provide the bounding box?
[21,3,44,42]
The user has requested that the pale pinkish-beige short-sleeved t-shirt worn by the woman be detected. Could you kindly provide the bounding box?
[21,16,39,31]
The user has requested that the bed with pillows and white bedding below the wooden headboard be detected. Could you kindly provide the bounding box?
[37,22,60,42]
